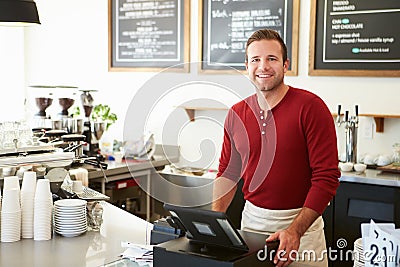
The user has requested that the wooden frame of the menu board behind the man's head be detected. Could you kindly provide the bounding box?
[198,0,300,76]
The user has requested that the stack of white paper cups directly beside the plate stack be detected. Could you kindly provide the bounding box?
[33,179,53,240]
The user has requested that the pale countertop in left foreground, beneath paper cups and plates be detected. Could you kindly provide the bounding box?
[0,202,153,267]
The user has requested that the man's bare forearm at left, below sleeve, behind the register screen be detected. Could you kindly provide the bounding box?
[212,176,237,212]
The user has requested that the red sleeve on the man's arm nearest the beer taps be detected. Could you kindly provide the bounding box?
[302,97,340,214]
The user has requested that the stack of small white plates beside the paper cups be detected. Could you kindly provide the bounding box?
[54,199,87,237]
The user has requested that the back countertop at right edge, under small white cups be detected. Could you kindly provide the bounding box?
[339,169,400,187]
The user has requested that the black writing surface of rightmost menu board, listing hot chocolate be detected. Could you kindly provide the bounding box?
[323,0,400,63]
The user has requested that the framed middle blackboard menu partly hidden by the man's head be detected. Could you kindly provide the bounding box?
[200,0,299,75]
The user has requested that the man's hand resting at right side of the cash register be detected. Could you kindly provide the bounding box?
[266,229,301,267]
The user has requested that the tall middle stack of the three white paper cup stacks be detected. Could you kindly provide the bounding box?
[21,171,36,238]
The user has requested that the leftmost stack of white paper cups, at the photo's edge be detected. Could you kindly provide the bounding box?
[1,188,21,242]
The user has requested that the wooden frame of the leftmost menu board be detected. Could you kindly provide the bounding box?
[108,0,190,73]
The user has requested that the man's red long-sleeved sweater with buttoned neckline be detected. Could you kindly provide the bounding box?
[217,87,340,214]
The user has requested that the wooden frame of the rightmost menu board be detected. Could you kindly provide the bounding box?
[308,0,400,77]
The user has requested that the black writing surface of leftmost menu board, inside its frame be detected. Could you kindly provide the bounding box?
[112,0,183,66]
